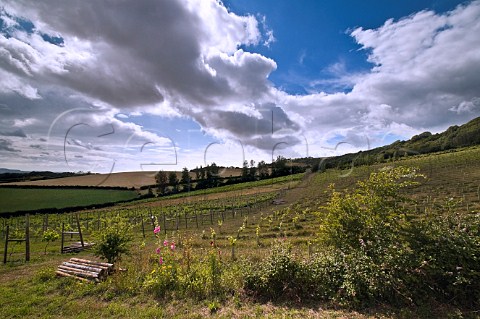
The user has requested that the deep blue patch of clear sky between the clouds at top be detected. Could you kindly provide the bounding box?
[224,0,463,94]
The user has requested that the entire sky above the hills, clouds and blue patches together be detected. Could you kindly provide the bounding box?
[0,0,480,173]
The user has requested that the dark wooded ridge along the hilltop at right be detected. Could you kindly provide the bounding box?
[295,117,480,171]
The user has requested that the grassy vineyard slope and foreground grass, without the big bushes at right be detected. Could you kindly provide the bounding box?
[0,148,480,318]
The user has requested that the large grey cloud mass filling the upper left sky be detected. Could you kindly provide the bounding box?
[0,0,286,164]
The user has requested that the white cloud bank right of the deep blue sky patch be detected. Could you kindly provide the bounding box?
[283,1,480,151]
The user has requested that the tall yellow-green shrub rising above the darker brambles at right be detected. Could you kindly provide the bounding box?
[319,167,422,251]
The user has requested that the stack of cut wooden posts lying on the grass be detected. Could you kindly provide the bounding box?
[56,258,113,282]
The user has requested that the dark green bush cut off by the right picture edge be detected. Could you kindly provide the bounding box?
[410,213,480,306]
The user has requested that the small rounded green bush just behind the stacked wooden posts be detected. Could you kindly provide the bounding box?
[93,215,133,263]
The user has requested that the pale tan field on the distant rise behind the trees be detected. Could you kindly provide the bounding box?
[4,168,241,188]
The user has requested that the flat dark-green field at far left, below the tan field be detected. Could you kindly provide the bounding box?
[0,188,137,213]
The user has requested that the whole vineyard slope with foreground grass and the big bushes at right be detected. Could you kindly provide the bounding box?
[0,148,480,318]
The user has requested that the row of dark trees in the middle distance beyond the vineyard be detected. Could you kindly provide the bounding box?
[155,156,306,195]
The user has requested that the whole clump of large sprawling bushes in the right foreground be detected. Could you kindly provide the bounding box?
[312,167,480,305]
